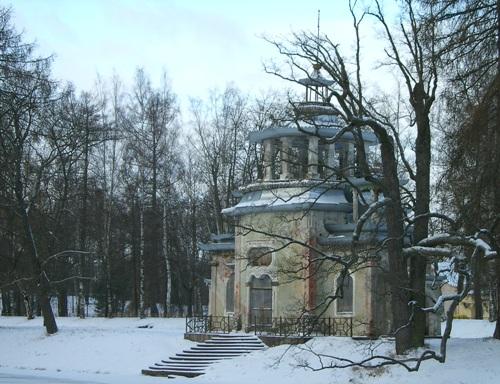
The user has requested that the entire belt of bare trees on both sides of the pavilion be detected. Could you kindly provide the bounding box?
[0,0,500,360]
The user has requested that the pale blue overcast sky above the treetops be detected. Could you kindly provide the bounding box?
[4,0,386,108]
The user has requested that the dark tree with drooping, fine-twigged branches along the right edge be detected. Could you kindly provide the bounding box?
[430,0,500,337]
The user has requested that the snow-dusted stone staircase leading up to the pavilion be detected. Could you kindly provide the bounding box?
[142,334,266,378]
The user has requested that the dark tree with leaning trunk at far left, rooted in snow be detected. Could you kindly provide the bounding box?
[0,8,57,334]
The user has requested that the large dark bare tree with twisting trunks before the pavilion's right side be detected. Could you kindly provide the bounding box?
[267,1,496,361]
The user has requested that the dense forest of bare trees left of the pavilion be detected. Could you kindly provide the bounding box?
[0,9,286,333]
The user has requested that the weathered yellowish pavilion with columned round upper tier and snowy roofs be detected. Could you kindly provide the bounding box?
[197,66,440,337]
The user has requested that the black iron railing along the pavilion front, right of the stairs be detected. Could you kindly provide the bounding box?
[250,316,352,337]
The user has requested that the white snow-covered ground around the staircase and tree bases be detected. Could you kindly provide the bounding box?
[0,317,500,384]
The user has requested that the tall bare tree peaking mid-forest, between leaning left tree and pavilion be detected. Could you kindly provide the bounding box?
[125,69,178,315]
